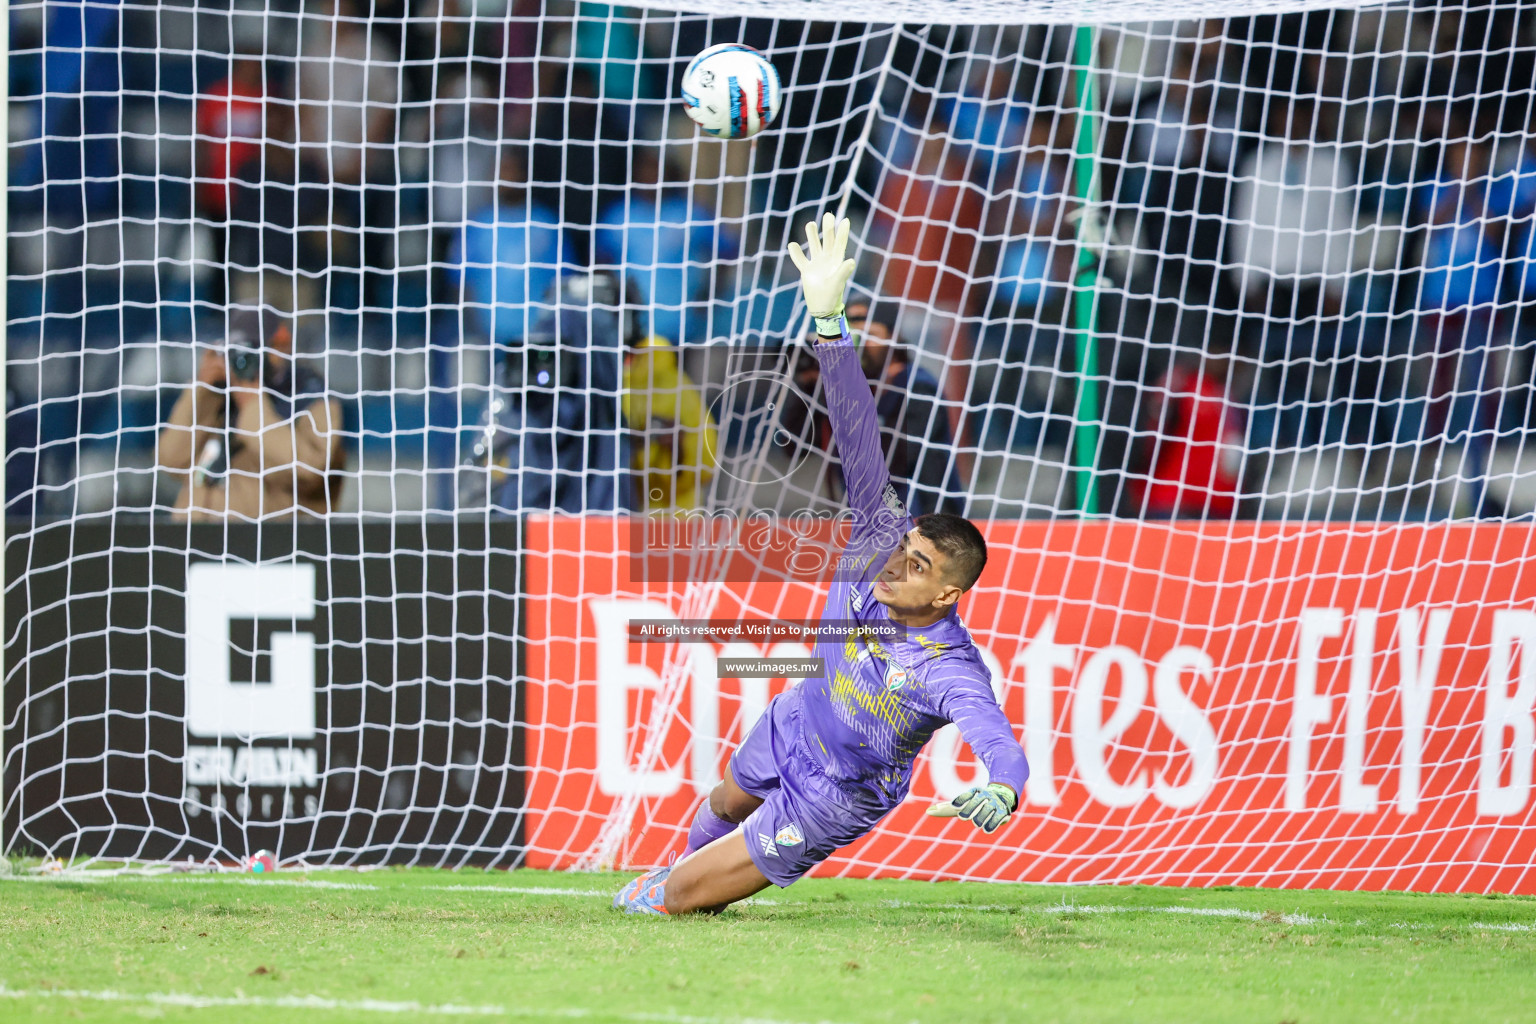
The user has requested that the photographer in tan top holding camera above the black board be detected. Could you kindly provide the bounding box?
[157,309,343,520]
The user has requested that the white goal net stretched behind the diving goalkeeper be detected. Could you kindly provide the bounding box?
[9,0,1536,892]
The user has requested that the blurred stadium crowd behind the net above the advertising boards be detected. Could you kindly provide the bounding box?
[8,0,1536,517]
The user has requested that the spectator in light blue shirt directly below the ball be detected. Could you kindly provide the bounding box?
[593,149,737,341]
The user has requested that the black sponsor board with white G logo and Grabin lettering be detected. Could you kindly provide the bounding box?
[3,519,524,866]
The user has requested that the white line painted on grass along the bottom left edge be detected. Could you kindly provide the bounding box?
[0,983,854,1024]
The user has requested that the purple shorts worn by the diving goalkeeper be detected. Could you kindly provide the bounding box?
[731,691,891,889]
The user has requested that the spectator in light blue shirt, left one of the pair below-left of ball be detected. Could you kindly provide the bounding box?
[444,144,571,345]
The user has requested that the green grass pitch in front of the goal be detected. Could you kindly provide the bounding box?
[0,869,1536,1024]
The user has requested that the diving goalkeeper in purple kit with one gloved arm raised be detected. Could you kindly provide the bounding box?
[613,213,1029,915]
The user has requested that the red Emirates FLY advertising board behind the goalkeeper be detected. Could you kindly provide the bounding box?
[525,517,1536,894]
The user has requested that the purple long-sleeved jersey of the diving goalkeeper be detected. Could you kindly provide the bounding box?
[786,333,1029,808]
